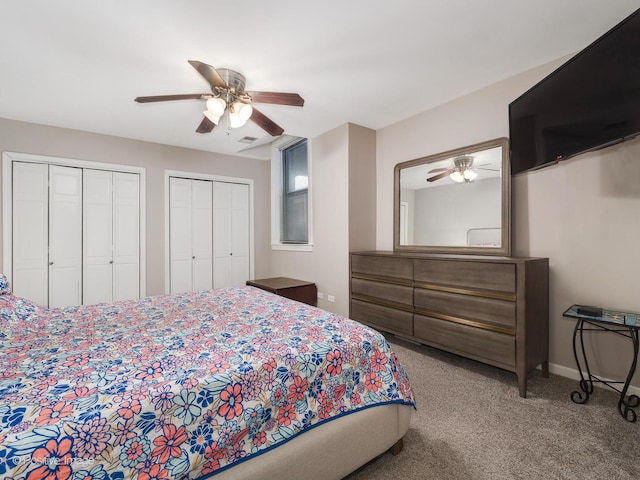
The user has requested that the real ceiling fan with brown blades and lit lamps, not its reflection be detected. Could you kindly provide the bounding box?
[135,60,304,137]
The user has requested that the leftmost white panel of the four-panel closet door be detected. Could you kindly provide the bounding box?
[11,162,49,306]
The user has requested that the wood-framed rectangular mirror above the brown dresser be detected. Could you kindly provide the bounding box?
[393,138,511,256]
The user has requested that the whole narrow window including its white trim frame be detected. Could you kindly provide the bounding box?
[271,137,312,251]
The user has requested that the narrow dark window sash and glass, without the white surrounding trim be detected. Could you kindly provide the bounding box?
[280,140,309,243]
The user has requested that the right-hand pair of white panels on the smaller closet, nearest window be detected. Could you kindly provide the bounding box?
[213,182,250,288]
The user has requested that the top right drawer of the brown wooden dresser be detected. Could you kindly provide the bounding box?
[414,259,516,294]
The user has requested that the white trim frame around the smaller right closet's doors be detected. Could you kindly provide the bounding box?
[164,170,255,294]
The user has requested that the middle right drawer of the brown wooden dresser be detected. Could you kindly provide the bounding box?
[414,288,516,332]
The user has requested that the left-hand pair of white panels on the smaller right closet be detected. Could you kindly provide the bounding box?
[169,177,213,293]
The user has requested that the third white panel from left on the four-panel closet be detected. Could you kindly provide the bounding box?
[83,169,113,305]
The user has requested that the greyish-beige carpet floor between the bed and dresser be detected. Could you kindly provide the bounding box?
[348,337,640,480]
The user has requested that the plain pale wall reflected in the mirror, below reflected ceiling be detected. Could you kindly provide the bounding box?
[408,177,502,247]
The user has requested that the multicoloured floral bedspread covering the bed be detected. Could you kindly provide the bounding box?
[0,287,413,480]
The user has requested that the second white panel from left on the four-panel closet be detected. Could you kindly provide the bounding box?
[49,165,82,307]
